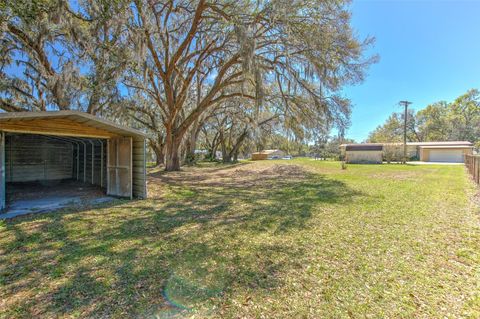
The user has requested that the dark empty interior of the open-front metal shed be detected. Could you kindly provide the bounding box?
[4,133,107,209]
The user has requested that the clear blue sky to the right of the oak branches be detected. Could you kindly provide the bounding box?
[345,0,480,142]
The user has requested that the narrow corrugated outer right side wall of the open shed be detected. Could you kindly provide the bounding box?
[132,138,147,198]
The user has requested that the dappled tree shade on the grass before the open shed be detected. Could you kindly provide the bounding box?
[0,165,364,318]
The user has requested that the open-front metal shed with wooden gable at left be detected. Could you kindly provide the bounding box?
[0,111,147,214]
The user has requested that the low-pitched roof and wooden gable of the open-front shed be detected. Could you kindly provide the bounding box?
[0,111,145,139]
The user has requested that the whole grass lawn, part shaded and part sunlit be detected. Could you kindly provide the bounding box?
[0,159,480,318]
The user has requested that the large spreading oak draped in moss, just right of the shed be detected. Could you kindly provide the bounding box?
[126,0,372,170]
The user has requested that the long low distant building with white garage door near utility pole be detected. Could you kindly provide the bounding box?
[340,141,473,163]
